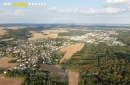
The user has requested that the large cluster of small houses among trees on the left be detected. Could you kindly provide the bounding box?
[0,39,69,70]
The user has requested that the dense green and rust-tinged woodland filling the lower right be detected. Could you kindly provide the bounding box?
[62,43,130,85]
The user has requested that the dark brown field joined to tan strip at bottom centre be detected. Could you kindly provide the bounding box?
[40,64,80,85]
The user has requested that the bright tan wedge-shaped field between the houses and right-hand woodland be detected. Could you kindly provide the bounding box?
[60,45,83,62]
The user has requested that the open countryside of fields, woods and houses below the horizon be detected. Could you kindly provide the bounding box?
[0,25,130,85]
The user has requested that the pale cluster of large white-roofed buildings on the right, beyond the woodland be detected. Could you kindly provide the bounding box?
[70,31,124,46]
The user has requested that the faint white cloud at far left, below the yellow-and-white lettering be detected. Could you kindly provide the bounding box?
[1,10,25,16]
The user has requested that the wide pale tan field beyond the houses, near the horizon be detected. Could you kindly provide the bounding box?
[29,29,68,40]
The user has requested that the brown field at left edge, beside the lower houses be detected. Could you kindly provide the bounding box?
[0,57,17,68]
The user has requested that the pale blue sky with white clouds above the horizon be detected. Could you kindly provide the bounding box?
[0,0,130,24]
